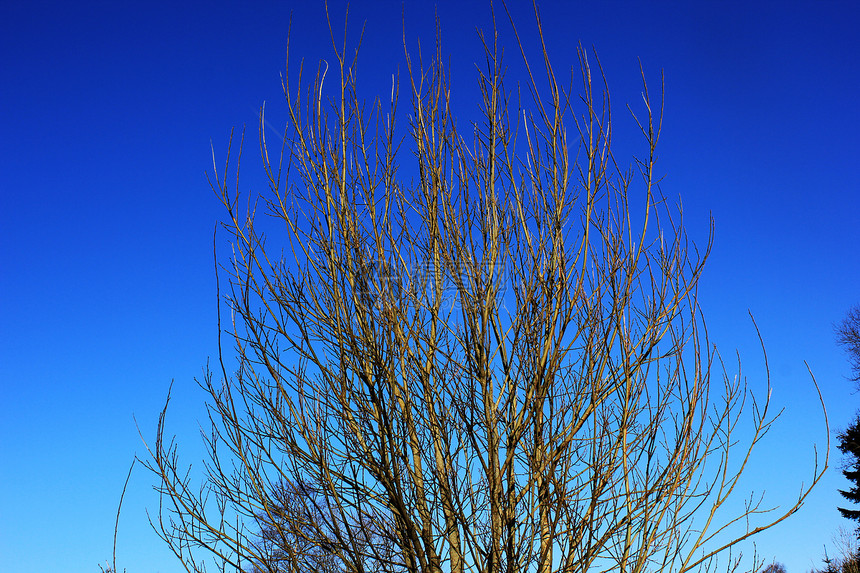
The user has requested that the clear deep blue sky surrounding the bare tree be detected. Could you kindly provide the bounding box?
[0,0,860,573]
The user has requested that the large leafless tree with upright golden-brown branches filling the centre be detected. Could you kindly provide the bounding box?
[141,6,826,573]
